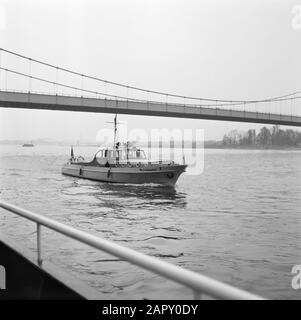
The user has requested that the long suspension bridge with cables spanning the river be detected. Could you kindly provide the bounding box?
[0,48,301,126]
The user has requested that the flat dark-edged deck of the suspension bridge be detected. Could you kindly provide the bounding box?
[0,91,301,126]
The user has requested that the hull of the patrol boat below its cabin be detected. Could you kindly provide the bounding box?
[62,163,186,186]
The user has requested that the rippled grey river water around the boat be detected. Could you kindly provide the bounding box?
[0,146,301,299]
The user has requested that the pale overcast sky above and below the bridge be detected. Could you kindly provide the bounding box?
[0,0,301,141]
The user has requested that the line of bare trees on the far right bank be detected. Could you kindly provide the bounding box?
[223,126,301,146]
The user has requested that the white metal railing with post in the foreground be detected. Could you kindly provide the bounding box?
[0,201,264,300]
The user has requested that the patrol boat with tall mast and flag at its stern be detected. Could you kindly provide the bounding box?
[62,116,187,186]
